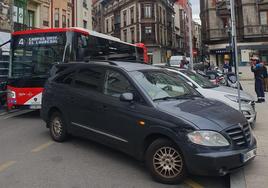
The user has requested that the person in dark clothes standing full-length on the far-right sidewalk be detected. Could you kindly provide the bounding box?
[251,57,265,103]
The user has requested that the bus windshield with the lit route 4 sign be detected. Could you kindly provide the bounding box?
[11,33,66,77]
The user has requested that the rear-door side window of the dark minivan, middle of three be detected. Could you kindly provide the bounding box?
[75,67,103,91]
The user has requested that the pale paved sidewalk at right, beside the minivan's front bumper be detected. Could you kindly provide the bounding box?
[236,80,268,188]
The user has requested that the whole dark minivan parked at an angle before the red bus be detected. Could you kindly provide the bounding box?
[41,61,256,184]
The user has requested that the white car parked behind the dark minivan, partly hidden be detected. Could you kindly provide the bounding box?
[168,67,257,127]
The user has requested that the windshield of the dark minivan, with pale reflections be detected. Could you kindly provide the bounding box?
[131,70,202,101]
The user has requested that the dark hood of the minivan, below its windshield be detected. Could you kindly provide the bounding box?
[156,98,247,131]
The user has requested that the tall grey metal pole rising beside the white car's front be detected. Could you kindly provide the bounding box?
[230,0,241,112]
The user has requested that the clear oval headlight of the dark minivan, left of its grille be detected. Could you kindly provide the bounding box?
[187,131,230,147]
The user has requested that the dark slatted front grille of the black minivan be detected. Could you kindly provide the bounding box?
[225,123,251,147]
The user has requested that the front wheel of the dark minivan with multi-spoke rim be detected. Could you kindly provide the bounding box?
[146,139,187,184]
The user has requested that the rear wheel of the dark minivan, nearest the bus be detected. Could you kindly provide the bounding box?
[48,112,68,142]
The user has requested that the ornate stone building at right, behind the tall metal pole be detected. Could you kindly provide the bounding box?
[200,0,268,66]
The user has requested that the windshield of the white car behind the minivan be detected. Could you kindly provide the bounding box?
[180,70,218,88]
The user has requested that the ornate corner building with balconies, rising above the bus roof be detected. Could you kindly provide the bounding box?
[93,0,175,63]
